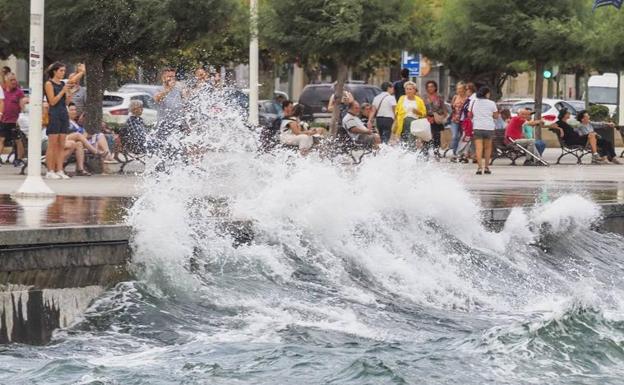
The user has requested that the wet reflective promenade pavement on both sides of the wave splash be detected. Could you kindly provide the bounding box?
[0,149,624,228]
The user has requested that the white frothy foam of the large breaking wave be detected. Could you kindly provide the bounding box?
[129,87,620,338]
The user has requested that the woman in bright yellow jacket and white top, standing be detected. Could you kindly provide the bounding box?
[394,81,427,148]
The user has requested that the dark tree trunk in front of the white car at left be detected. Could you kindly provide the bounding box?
[85,55,104,132]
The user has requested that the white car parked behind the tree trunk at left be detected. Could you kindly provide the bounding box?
[102,91,157,127]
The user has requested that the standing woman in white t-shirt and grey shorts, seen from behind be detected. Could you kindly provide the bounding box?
[469,87,498,175]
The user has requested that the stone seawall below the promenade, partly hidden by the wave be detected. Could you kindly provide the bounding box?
[0,204,624,345]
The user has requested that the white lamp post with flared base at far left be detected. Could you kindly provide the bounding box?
[13,0,54,197]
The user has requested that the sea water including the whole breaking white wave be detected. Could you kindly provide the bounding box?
[0,87,624,385]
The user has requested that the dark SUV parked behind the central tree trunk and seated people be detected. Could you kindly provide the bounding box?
[299,82,381,124]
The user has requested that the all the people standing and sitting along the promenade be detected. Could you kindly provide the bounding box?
[0,62,619,179]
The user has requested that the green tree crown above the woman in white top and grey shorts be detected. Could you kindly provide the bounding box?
[426,0,586,106]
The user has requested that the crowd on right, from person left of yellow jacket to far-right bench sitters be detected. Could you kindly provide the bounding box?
[368,70,620,171]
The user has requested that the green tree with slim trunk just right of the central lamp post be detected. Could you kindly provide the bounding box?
[260,0,431,135]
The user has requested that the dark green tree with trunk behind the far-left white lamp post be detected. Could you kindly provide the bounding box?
[0,0,241,129]
